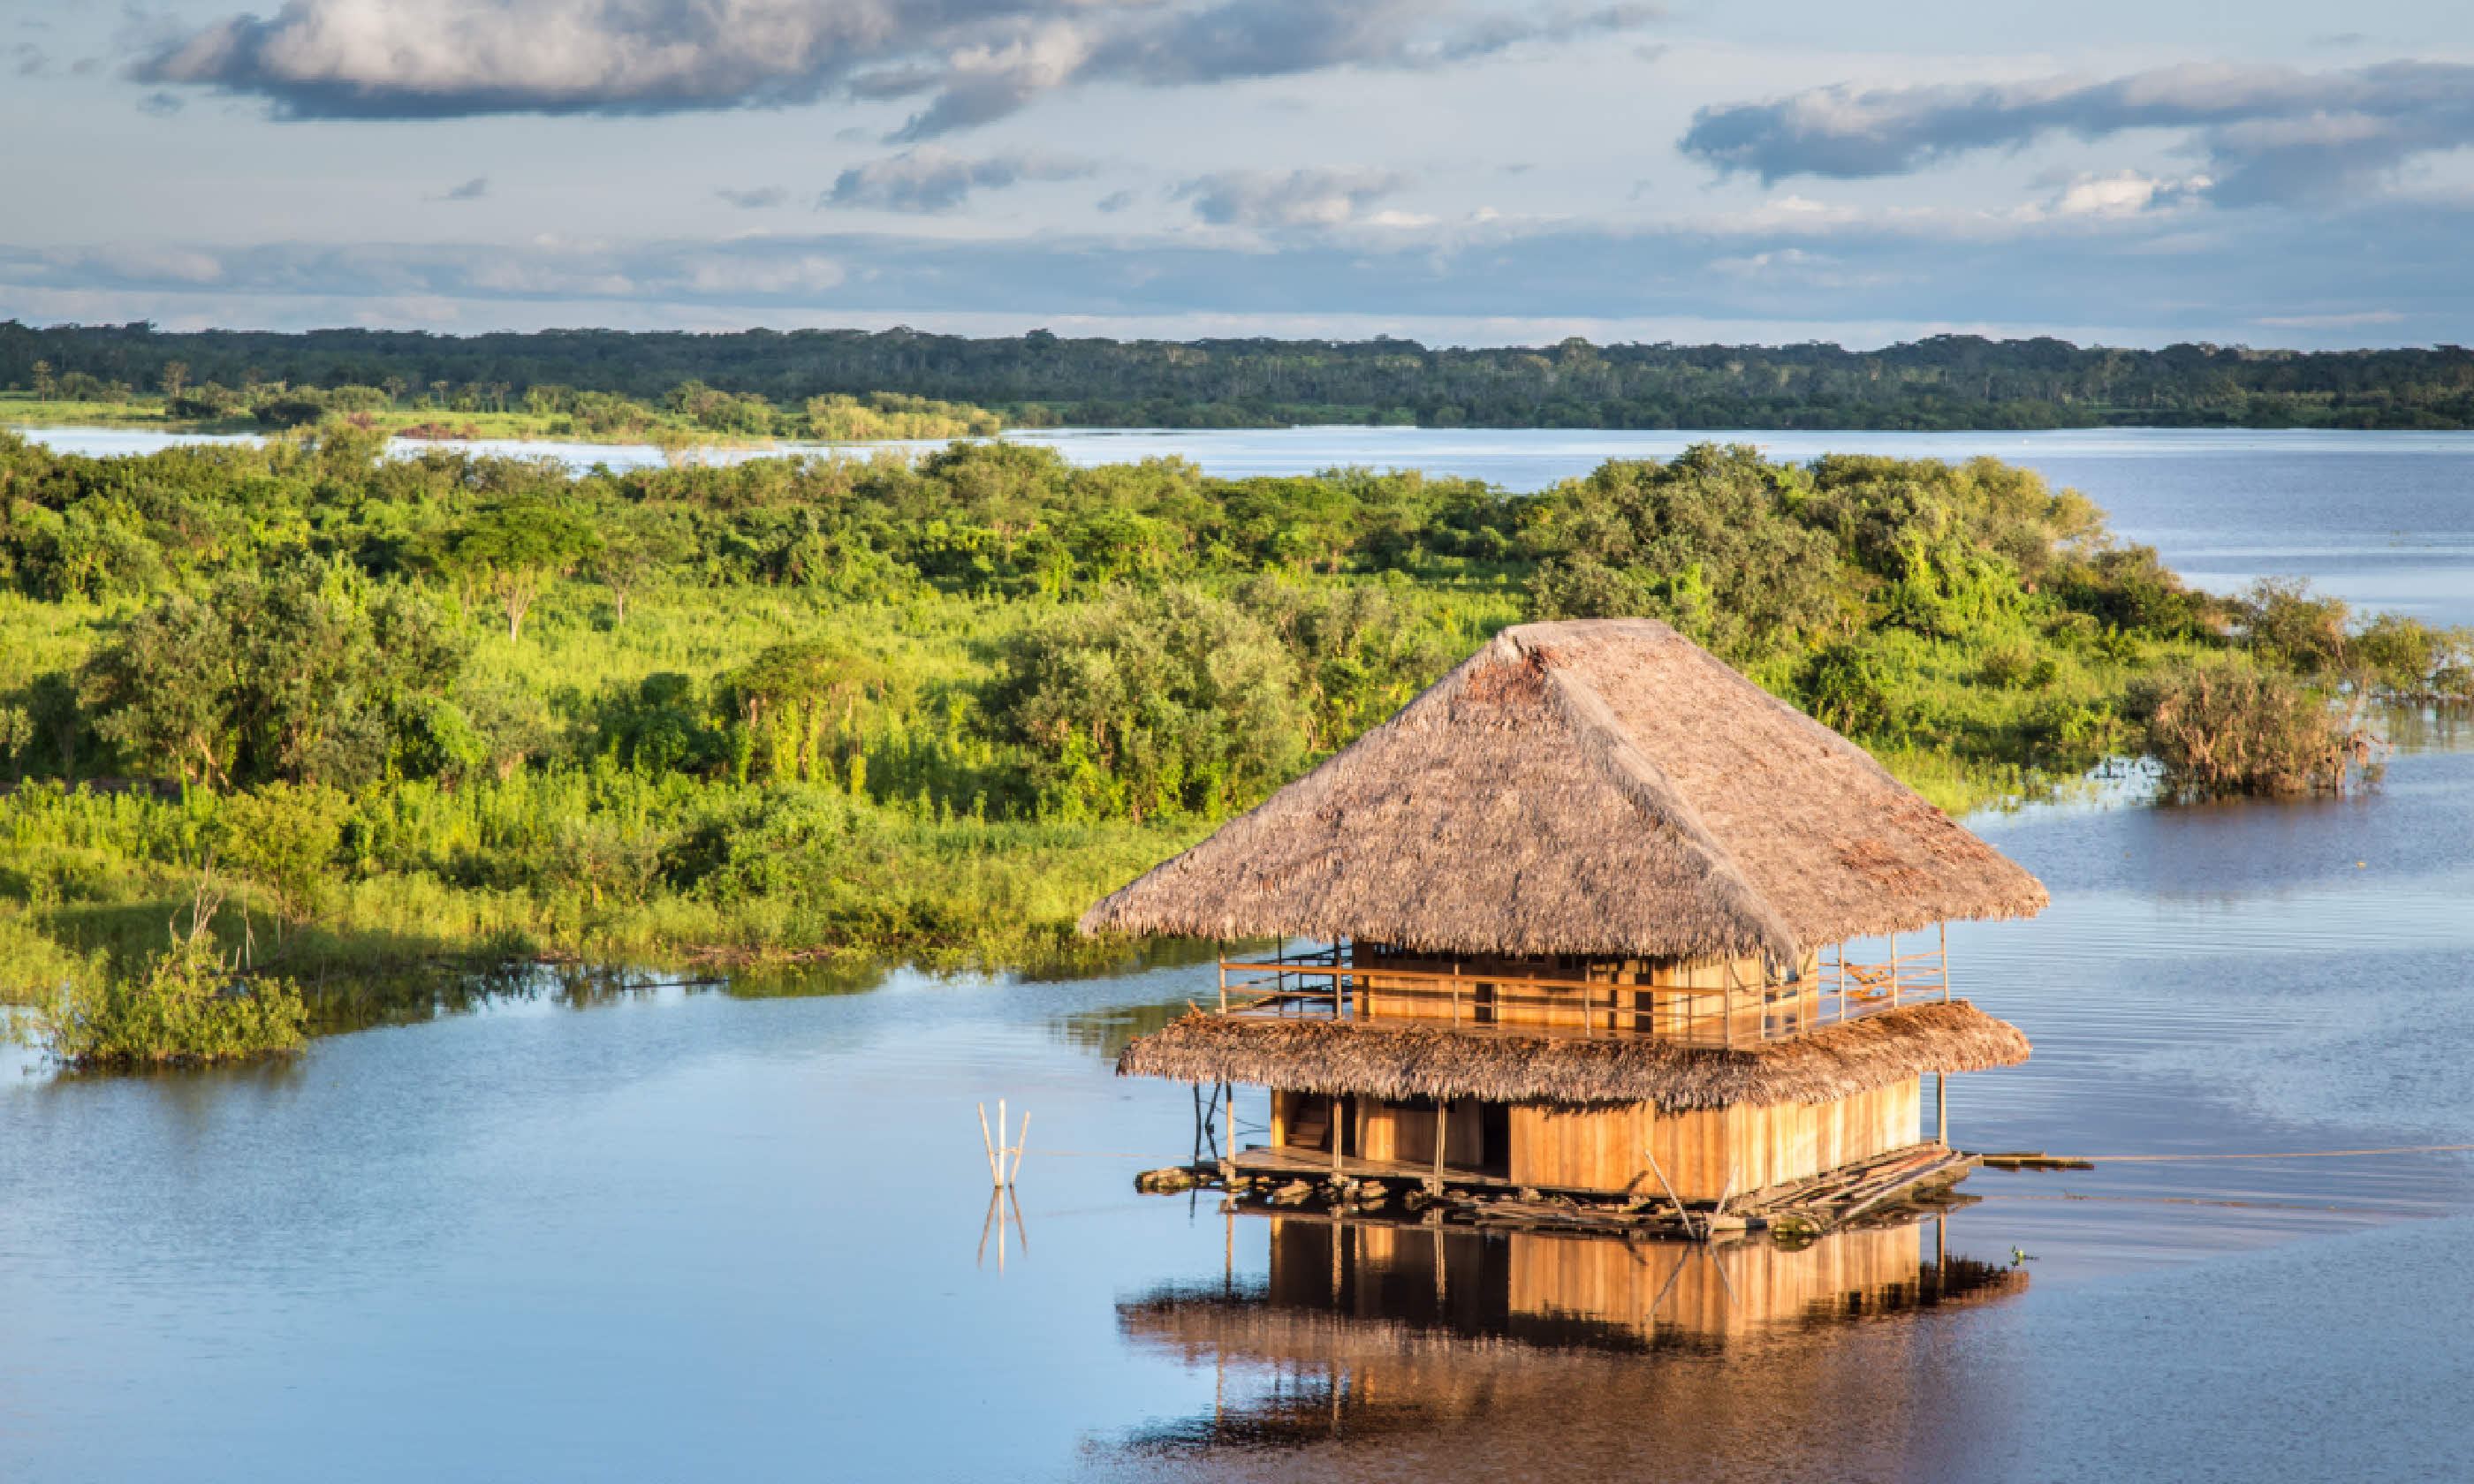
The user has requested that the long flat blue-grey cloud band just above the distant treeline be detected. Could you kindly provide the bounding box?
[14,198,2474,344]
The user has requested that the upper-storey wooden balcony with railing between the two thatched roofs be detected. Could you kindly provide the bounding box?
[1219,937,1949,1046]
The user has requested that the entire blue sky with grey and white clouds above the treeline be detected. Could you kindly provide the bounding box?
[0,0,2474,346]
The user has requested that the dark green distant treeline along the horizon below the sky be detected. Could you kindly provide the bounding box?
[0,322,2474,428]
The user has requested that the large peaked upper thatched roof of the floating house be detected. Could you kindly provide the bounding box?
[1081,618,2046,967]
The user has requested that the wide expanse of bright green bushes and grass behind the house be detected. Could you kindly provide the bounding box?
[0,420,2474,1046]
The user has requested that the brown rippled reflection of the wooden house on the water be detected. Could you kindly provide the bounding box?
[1119,1217,2026,1457]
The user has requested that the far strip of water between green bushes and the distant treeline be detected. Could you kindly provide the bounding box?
[32,428,2474,624]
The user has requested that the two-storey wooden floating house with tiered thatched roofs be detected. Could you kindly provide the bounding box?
[1081,618,2046,1202]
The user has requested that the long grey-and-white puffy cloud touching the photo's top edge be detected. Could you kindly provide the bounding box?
[131,0,1655,141]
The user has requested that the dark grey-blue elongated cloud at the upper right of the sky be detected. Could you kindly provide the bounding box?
[1680,62,2474,205]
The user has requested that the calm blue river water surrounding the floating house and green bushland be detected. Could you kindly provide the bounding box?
[0,430,2474,1481]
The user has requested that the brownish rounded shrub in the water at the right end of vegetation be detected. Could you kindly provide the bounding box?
[2128,665,2375,797]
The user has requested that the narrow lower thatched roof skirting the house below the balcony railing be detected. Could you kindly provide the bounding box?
[1116,999,2029,1113]
